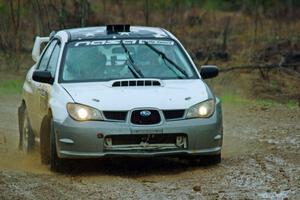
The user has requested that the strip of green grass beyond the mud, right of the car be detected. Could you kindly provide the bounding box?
[220,94,298,109]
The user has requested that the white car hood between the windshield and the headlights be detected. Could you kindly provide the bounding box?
[62,79,208,110]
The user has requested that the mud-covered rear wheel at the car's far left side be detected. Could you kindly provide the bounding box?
[19,105,35,154]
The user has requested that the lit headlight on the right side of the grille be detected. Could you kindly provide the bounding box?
[186,99,215,118]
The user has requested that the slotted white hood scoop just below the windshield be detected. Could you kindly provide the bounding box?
[111,79,163,87]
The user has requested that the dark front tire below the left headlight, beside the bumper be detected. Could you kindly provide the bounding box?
[50,120,65,172]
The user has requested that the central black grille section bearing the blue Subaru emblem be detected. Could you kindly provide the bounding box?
[131,110,161,125]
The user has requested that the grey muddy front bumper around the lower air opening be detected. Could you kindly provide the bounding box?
[54,106,223,158]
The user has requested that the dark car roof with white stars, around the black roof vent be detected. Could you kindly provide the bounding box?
[65,26,171,40]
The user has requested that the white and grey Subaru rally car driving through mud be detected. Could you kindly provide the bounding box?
[18,25,223,171]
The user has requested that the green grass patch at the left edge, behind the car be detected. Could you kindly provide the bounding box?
[0,79,23,95]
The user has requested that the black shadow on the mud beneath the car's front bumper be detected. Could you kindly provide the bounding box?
[63,157,218,178]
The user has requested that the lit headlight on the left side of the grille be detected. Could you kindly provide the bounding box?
[67,103,103,121]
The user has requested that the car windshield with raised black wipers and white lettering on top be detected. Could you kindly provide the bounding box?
[60,39,197,82]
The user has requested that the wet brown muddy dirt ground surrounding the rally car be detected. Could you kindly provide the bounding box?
[0,95,300,199]
